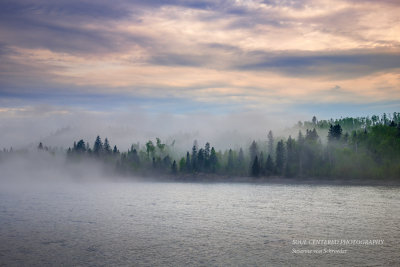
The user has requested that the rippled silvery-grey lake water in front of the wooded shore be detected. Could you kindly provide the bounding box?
[0,182,400,266]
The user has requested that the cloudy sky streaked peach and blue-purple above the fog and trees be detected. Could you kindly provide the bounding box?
[0,0,400,149]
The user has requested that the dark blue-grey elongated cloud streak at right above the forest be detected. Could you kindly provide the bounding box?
[238,50,400,79]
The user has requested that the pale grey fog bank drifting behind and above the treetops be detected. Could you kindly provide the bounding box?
[0,106,311,151]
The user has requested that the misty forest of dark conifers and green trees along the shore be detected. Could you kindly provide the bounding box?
[0,113,400,179]
